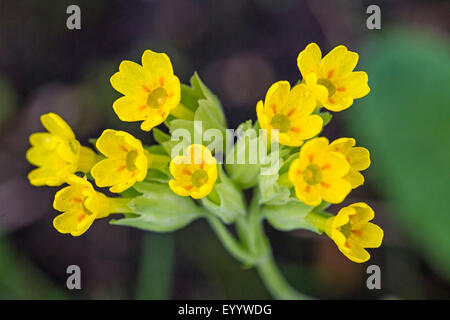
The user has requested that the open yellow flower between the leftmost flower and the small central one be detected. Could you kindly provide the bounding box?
[91,129,148,193]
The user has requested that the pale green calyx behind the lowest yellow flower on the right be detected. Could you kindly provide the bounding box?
[263,200,321,233]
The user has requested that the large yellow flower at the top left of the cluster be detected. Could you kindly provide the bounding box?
[111,50,181,131]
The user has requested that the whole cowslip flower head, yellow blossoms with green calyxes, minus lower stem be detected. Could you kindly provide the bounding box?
[27,43,383,298]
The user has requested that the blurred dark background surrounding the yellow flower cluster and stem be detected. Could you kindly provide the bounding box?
[0,0,450,299]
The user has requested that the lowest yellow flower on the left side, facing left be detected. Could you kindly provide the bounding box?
[53,176,112,236]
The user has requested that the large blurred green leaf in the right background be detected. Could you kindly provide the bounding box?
[347,30,450,280]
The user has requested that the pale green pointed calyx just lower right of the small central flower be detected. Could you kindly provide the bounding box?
[200,165,246,224]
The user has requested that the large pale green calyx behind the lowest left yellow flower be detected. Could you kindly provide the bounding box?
[111,182,201,232]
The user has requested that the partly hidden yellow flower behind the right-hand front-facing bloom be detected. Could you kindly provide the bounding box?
[330,138,370,189]
